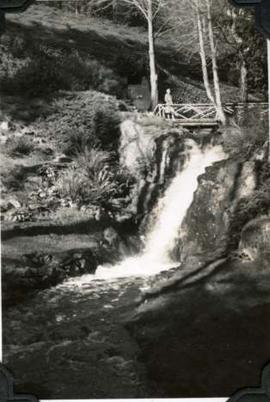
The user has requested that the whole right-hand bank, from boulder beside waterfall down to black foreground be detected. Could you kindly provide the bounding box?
[126,155,270,397]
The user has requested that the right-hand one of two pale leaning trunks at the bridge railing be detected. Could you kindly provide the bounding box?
[206,0,226,125]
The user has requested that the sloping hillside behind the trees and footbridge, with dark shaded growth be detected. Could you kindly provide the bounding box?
[0,4,262,102]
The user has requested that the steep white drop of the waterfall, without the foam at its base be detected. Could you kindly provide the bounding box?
[144,140,225,263]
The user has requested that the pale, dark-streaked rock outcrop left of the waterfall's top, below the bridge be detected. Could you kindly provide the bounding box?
[119,114,192,226]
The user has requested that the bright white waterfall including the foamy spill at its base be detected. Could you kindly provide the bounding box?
[66,140,225,282]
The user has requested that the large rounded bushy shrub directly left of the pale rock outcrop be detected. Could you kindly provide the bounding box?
[43,91,120,155]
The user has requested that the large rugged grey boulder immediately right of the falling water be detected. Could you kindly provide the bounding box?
[177,159,257,266]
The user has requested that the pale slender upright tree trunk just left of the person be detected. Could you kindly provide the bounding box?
[147,0,158,110]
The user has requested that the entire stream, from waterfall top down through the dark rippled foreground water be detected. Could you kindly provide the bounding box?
[4,140,225,399]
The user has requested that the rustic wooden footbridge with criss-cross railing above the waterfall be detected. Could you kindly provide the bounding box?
[154,102,268,127]
